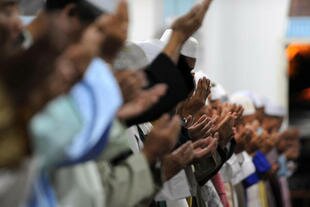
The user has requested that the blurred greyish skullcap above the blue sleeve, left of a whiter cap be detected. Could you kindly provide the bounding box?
[113,43,148,70]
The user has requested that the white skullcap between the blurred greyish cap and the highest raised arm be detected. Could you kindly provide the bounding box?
[137,39,164,63]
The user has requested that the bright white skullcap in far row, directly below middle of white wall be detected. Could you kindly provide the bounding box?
[229,94,256,116]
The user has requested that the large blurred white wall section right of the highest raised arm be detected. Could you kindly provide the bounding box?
[199,0,289,106]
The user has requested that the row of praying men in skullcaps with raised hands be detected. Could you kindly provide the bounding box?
[0,0,300,207]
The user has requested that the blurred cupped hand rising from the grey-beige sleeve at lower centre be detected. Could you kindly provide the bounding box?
[143,115,181,163]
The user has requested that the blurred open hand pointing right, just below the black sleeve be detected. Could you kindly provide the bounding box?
[117,84,167,121]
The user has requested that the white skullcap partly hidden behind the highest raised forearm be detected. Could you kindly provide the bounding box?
[160,29,199,59]
